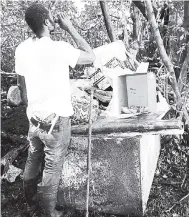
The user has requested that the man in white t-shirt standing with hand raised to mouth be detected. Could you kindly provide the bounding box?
[15,3,95,217]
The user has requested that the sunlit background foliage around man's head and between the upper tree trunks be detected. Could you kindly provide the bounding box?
[1,0,186,72]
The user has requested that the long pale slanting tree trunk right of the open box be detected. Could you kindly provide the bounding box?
[145,0,189,123]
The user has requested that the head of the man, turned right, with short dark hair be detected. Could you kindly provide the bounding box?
[25,3,55,35]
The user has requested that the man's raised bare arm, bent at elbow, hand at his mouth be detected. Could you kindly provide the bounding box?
[55,15,95,65]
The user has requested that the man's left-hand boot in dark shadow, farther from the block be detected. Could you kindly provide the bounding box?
[23,178,39,216]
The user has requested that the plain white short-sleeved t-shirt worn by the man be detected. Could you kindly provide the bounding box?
[15,37,80,117]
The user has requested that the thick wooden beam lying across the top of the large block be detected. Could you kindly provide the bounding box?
[72,114,183,135]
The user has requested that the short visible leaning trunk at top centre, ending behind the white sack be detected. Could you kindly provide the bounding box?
[100,0,116,42]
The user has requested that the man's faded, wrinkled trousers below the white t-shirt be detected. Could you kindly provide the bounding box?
[24,117,71,212]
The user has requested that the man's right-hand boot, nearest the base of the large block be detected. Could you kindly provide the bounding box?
[39,186,63,217]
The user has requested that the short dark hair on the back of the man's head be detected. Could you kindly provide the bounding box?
[25,3,49,34]
